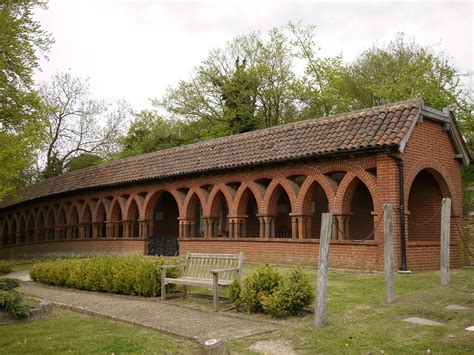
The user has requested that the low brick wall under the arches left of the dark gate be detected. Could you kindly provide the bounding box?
[0,238,145,259]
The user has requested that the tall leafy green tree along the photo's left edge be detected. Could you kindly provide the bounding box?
[0,0,52,196]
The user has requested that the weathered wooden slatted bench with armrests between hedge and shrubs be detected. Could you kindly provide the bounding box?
[161,252,244,311]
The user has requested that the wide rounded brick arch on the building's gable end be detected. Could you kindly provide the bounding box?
[405,158,461,210]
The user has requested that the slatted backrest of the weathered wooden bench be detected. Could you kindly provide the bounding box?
[183,252,244,281]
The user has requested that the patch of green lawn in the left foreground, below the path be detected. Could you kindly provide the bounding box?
[0,308,198,354]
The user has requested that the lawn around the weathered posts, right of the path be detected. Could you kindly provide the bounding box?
[228,270,474,354]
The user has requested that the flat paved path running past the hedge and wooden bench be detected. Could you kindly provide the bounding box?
[19,282,279,342]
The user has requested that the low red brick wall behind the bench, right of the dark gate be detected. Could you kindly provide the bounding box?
[179,239,383,271]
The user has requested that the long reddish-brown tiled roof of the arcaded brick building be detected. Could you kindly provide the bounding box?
[0,99,422,208]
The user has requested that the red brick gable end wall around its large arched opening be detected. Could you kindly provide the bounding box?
[403,119,462,270]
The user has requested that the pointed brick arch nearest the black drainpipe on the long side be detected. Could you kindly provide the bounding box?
[333,167,378,213]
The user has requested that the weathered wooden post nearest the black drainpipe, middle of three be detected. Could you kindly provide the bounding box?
[383,203,395,303]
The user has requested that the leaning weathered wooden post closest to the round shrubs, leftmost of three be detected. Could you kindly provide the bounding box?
[314,212,332,328]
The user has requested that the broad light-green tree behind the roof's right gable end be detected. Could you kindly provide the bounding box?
[343,33,474,151]
